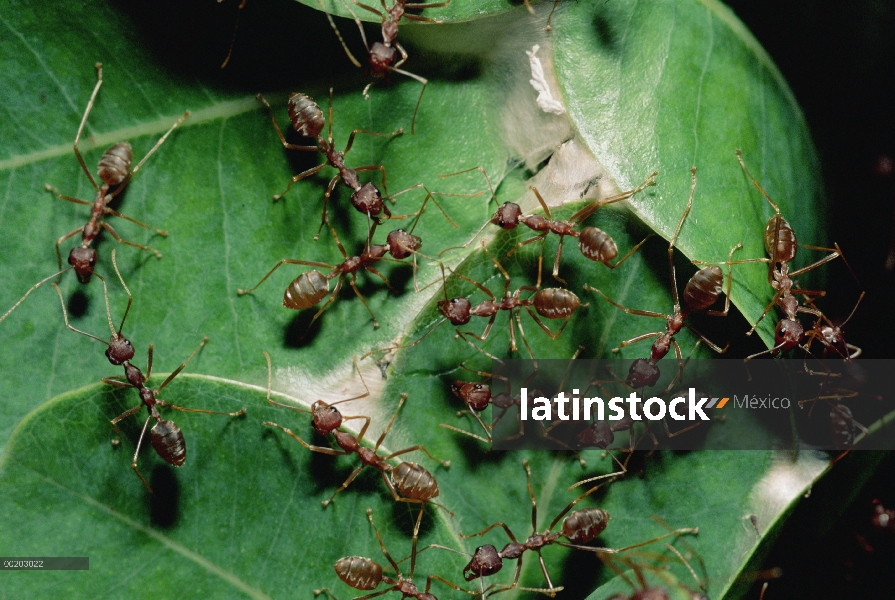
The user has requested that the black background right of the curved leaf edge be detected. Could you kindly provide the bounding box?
[728,0,895,600]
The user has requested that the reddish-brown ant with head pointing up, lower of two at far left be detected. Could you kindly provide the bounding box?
[53,250,246,493]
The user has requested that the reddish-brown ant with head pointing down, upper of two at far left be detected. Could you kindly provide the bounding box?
[0,63,190,322]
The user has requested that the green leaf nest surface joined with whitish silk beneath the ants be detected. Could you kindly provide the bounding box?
[0,0,868,597]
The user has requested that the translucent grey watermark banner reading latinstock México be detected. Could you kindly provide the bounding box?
[490,358,895,451]
